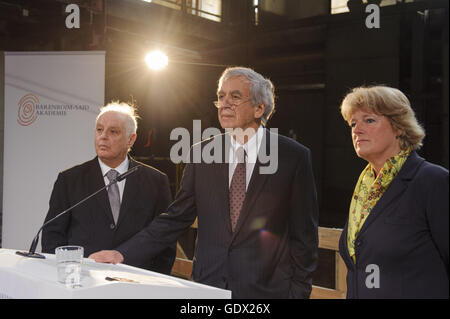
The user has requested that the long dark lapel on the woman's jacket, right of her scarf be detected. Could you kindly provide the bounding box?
[358,152,424,237]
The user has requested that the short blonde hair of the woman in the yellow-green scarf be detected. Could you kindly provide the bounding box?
[341,85,425,150]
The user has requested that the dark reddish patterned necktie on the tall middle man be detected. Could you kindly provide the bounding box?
[230,147,246,232]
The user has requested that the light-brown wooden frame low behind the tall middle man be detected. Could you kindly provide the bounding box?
[172,220,347,299]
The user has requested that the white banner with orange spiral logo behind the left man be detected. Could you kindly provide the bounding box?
[2,52,105,250]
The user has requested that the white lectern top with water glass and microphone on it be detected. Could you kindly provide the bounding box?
[0,249,231,299]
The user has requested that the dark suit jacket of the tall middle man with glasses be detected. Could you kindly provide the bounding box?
[118,130,318,298]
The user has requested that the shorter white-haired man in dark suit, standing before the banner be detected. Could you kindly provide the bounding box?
[42,103,176,274]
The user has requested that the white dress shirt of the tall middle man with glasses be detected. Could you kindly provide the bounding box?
[228,125,264,190]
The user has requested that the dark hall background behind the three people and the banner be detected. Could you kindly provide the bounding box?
[0,0,449,286]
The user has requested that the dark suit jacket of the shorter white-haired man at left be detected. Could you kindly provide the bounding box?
[42,157,176,274]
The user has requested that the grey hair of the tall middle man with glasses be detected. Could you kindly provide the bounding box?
[218,67,275,126]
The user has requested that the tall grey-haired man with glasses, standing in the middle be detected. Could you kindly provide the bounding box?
[91,68,318,298]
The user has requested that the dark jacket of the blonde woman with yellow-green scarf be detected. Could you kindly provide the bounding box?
[339,152,449,298]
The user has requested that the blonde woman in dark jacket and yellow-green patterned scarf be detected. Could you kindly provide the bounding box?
[339,86,449,298]
